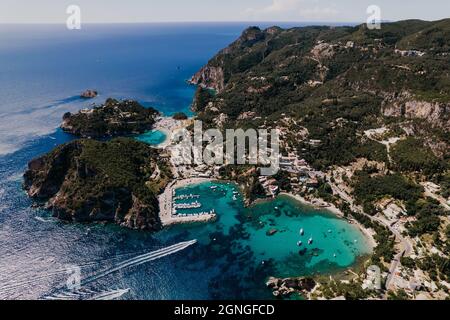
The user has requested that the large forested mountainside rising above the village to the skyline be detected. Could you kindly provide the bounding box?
[194,20,450,176]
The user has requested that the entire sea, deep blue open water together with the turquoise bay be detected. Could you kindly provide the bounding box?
[0,23,371,300]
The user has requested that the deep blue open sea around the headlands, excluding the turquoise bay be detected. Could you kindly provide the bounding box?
[0,24,370,299]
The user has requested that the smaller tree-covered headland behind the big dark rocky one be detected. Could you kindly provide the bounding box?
[61,99,158,138]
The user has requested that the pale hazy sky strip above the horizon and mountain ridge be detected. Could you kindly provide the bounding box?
[0,0,450,23]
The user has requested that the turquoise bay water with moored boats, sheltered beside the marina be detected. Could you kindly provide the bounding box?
[167,182,371,277]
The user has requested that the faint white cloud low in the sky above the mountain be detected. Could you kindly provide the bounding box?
[244,0,339,21]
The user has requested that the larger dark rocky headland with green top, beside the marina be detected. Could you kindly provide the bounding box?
[24,138,165,230]
